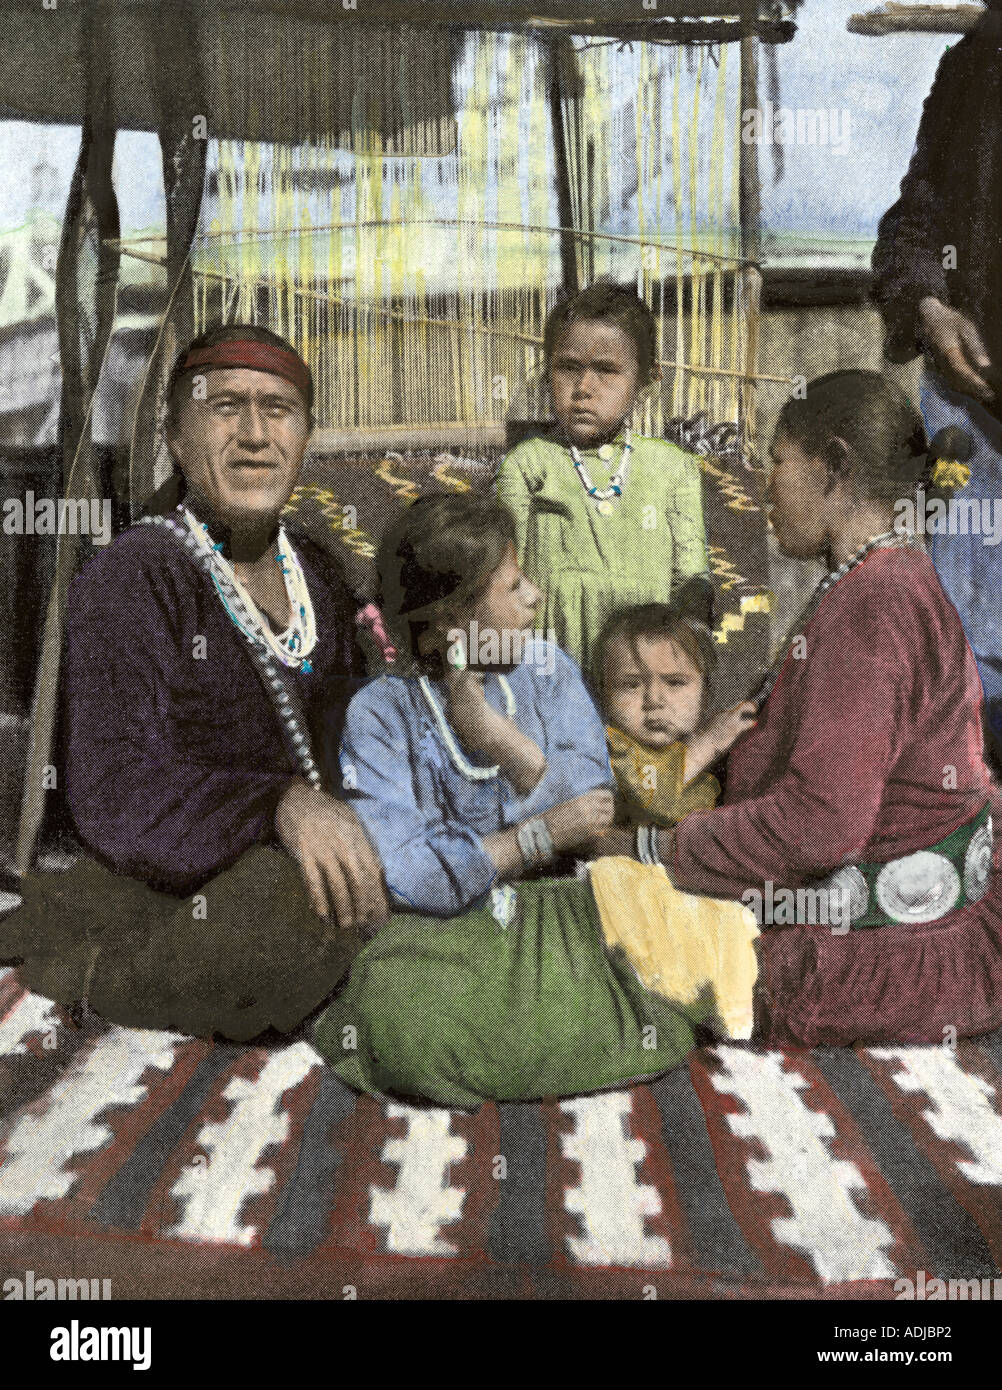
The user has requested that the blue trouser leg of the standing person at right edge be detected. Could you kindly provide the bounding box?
[921,371,1002,748]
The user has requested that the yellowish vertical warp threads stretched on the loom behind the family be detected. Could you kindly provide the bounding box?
[192,31,745,450]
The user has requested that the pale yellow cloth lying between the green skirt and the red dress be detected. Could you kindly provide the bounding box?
[589,856,759,1038]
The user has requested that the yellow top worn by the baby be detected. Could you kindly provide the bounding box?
[606,726,720,826]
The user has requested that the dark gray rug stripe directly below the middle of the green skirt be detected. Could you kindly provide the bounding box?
[488,1101,550,1265]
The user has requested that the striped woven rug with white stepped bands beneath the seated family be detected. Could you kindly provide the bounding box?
[0,972,1002,1298]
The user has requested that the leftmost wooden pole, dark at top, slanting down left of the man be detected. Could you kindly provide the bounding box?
[14,0,121,874]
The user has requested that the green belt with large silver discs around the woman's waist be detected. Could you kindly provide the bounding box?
[813,805,992,931]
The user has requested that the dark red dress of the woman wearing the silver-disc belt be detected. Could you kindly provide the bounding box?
[670,549,1002,1047]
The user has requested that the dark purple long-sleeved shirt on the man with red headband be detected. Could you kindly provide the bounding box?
[67,525,364,894]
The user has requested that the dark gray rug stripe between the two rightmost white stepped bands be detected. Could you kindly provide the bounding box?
[810,1048,998,1279]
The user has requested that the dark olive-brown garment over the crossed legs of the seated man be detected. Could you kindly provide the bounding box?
[0,847,361,1043]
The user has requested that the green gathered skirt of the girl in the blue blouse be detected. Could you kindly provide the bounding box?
[314,880,694,1109]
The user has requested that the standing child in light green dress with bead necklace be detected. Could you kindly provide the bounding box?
[498,281,707,670]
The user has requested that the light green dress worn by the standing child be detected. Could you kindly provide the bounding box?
[498,432,707,673]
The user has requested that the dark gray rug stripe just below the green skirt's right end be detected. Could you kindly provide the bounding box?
[649,1066,764,1279]
